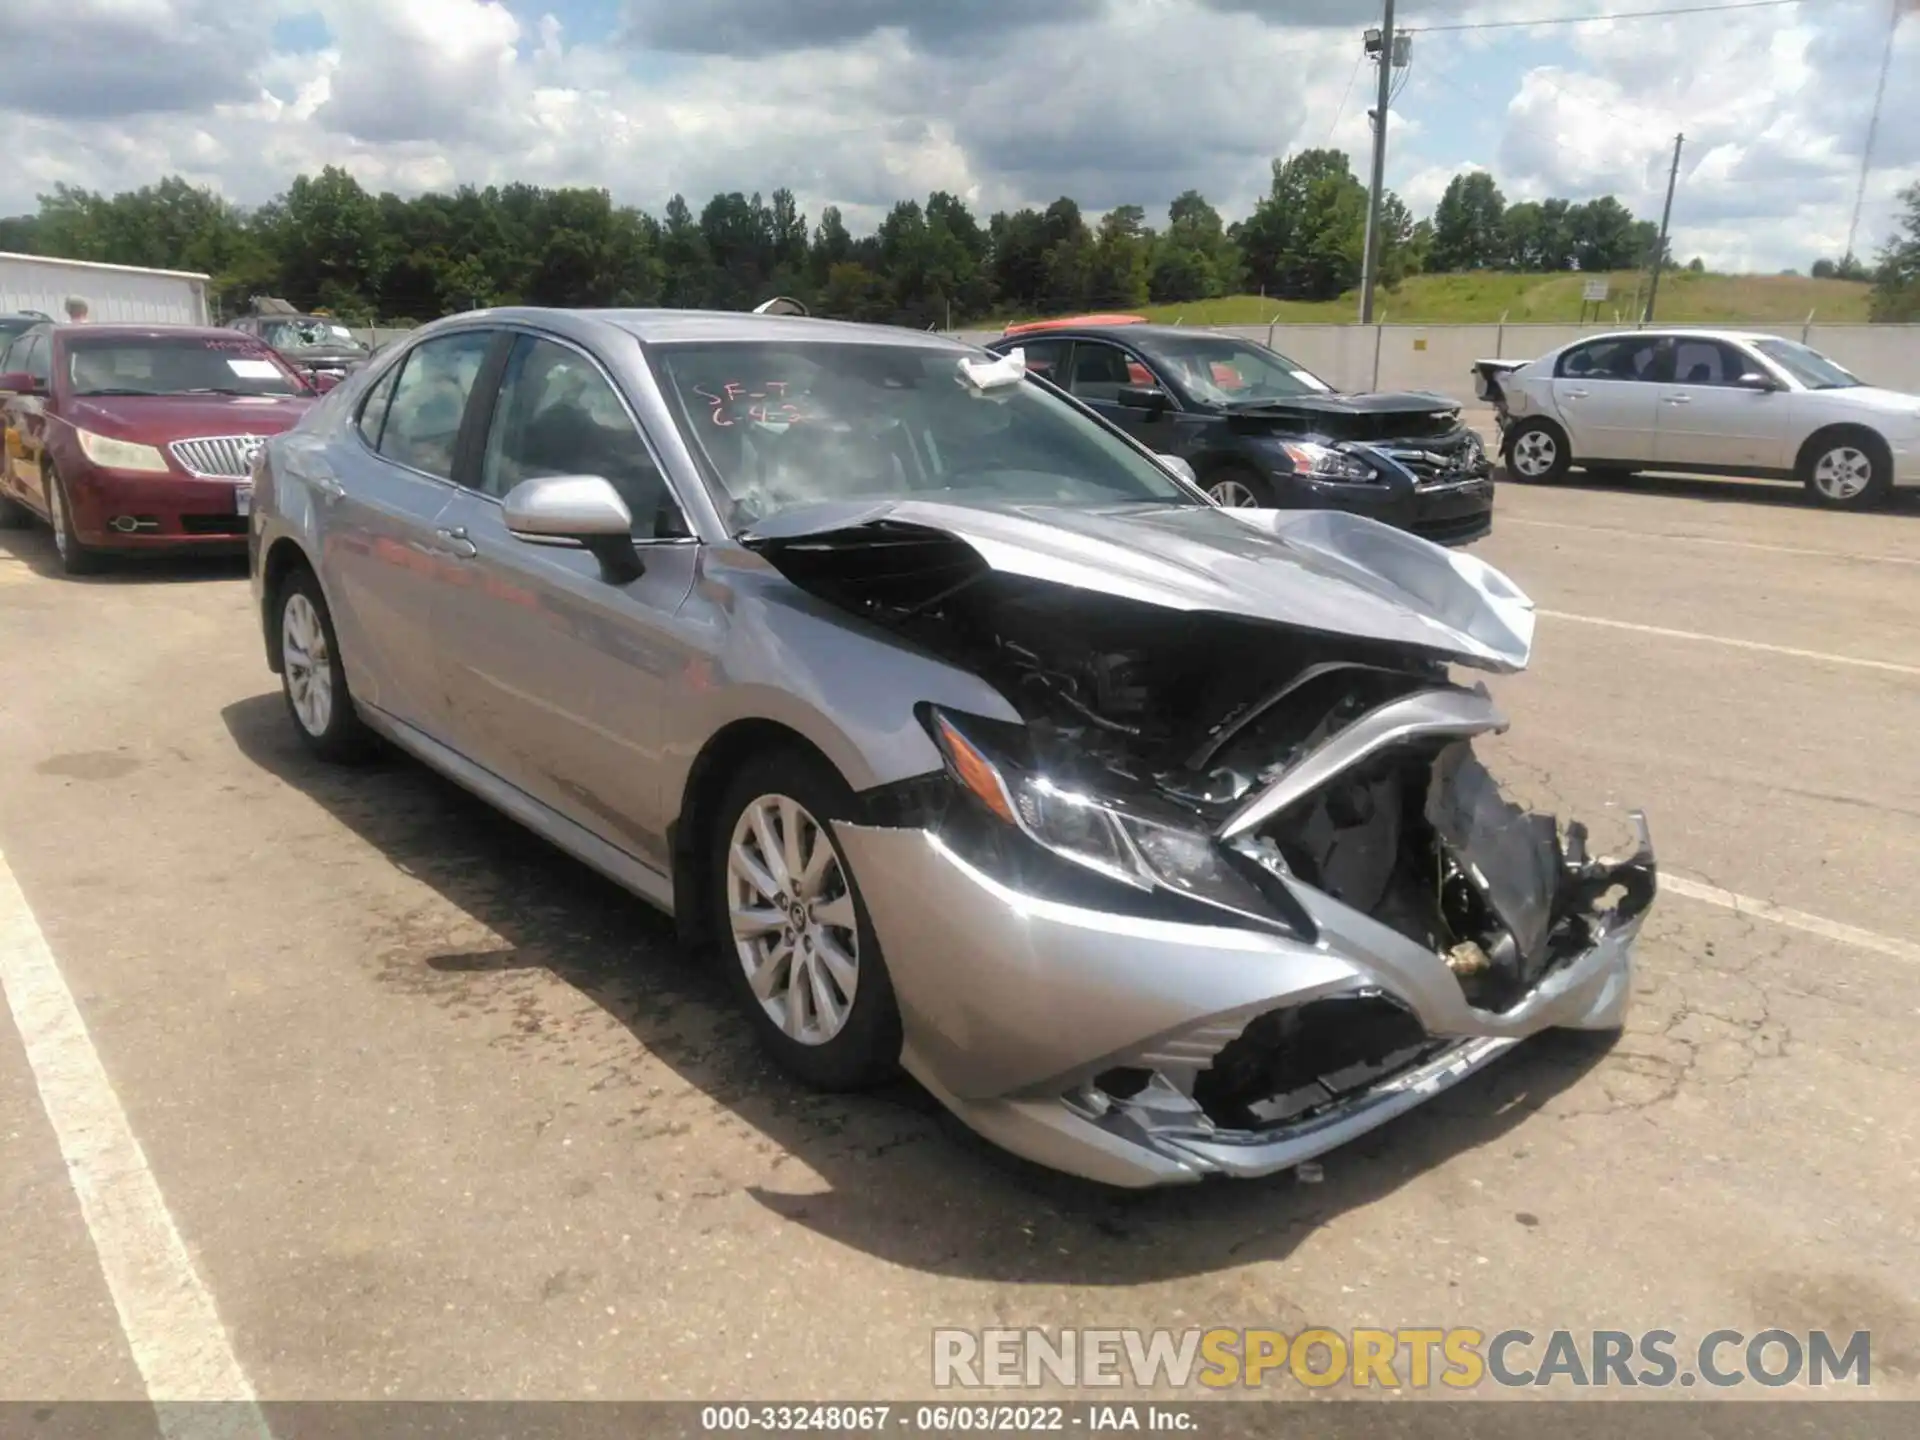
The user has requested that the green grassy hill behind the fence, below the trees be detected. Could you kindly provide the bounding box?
[1140,271,1872,324]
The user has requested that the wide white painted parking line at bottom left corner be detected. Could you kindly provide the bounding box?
[0,854,269,1436]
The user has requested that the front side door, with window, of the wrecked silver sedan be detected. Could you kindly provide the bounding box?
[436,334,701,870]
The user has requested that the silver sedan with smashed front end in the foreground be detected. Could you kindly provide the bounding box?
[252,301,1655,1187]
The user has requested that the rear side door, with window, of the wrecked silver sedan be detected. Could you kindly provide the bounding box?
[321,328,501,741]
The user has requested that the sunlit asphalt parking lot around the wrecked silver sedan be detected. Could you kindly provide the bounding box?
[0,470,1920,1400]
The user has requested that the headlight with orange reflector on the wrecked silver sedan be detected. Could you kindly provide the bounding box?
[927,708,1279,924]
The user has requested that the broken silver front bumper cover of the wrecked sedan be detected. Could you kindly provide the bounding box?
[835,806,1653,1187]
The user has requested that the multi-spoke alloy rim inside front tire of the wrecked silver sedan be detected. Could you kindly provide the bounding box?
[726,795,860,1044]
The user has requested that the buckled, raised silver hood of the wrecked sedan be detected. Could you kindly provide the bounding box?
[741,499,1534,672]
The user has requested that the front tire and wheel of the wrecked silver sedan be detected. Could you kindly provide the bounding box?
[703,749,900,1091]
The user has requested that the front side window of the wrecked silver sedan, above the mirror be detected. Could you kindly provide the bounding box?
[480,336,689,540]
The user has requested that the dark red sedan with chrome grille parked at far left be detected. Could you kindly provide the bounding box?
[0,324,315,574]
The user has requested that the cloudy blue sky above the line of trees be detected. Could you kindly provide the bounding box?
[0,0,1920,269]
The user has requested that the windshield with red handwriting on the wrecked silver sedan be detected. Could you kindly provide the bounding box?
[655,342,1204,530]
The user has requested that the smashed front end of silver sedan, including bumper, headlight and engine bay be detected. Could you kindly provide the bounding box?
[744,513,1655,1185]
